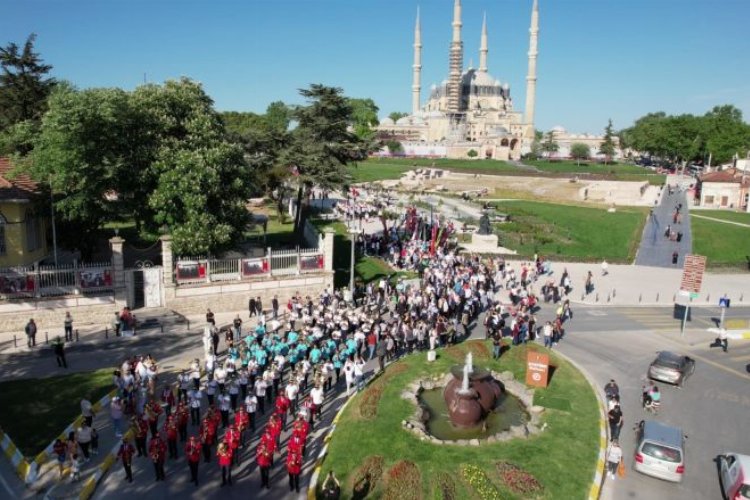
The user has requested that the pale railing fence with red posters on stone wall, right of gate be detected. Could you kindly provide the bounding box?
[174,248,325,285]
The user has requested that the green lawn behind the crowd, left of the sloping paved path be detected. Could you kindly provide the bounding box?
[493,201,648,262]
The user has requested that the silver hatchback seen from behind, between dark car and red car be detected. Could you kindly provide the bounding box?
[633,420,685,483]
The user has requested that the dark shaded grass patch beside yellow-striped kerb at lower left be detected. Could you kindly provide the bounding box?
[0,368,113,457]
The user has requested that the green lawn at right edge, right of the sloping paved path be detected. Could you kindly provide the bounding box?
[690,217,750,269]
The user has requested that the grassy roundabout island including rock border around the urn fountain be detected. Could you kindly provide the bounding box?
[318,340,600,499]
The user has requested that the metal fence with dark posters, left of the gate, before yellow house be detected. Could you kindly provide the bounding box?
[0,262,114,300]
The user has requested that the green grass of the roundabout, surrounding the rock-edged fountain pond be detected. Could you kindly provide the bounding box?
[319,341,599,499]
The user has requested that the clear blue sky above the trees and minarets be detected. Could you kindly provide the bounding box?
[0,0,750,133]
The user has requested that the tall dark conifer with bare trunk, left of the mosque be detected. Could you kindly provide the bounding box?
[278,84,370,238]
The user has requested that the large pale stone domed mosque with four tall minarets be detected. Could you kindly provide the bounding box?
[378,0,539,160]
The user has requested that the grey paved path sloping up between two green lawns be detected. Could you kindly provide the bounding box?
[635,187,693,268]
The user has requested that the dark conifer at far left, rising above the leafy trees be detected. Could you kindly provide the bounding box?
[0,33,55,131]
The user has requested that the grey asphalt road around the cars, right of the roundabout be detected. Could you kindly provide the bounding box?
[559,308,750,500]
